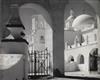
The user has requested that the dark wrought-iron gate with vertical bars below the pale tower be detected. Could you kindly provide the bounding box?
[29,49,50,76]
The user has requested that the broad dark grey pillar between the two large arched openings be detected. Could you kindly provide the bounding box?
[50,4,64,76]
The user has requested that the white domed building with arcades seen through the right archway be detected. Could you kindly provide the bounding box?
[64,10,98,72]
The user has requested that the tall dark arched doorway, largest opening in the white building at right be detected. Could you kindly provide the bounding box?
[89,48,98,71]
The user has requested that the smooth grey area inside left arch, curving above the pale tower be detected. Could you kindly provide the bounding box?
[19,3,52,34]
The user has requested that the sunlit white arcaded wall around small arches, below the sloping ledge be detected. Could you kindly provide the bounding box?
[65,43,97,72]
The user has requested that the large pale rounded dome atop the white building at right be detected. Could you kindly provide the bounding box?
[72,14,95,30]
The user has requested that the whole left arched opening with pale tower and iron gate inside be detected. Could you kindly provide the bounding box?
[20,3,53,76]
